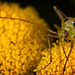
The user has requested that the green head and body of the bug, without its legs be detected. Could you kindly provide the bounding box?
[58,17,75,41]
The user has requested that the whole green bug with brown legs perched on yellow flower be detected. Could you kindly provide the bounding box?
[44,6,75,74]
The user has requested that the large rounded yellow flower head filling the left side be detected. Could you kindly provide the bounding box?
[0,2,48,75]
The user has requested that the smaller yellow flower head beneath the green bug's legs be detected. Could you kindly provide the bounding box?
[34,40,75,75]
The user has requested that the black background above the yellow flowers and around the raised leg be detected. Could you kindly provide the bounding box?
[2,0,75,28]
